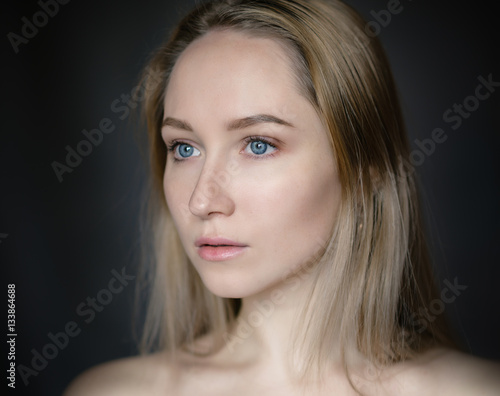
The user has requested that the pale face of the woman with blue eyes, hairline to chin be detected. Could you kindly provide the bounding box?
[162,31,340,298]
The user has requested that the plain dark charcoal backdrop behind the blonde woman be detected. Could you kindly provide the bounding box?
[0,0,500,395]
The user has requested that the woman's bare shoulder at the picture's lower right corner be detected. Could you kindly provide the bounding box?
[396,349,500,396]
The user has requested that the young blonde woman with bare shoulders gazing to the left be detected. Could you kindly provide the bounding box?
[66,0,500,396]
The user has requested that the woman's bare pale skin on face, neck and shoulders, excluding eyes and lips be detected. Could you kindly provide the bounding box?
[65,31,500,396]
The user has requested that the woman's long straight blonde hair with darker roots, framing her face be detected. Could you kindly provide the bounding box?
[135,0,452,386]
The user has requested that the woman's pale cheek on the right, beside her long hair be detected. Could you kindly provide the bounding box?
[238,160,340,258]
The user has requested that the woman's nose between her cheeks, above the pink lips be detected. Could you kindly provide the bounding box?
[189,164,235,220]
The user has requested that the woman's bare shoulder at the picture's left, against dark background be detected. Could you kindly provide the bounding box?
[63,353,173,396]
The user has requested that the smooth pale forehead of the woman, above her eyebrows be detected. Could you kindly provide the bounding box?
[165,31,299,113]
